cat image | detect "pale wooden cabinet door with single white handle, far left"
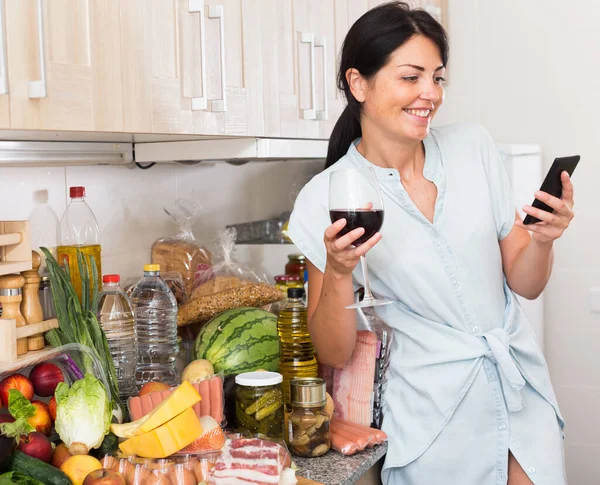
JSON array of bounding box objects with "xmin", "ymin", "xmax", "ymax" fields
[{"xmin": 5, "ymin": 0, "xmax": 123, "ymax": 132}]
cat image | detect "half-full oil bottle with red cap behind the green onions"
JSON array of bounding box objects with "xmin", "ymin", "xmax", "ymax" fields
[{"xmin": 56, "ymin": 187, "xmax": 102, "ymax": 301}]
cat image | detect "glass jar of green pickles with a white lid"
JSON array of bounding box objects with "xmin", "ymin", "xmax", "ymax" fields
[{"xmin": 235, "ymin": 372, "xmax": 283, "ymax": 439}]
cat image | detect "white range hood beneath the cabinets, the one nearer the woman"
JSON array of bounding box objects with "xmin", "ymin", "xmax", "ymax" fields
[{"xmin": 135, "ymin": 138, "xmax": 329, "ymax": 164}]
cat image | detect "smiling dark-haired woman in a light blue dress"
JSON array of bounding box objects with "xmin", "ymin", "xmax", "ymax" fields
[{"xmin": 289, "ymin": 2, "xmax": 573, "ymax": 485}]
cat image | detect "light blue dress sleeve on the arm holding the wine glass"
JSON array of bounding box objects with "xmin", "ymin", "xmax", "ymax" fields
[{"xmin": 288, "ymin": 175, "xmax": 331, "ymax": 273}]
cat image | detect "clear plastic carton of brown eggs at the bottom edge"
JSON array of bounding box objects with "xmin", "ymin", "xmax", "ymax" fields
[{"xmin": 101, "ymin": 452, "xmax": 221, "ymax": 485}]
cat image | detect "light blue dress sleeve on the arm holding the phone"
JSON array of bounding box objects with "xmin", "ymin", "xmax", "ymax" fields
[{"xmin": 481, "ymin": 128, "xmax": 516, "ymax": 241}]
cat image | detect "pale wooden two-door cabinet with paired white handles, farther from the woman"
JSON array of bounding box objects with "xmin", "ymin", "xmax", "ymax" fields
[{"xmin": 120, "ymin": 0, "xmax": 263, "ymax": 135}]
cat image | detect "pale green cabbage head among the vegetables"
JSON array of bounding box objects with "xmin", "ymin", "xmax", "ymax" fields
[{"xmin": 54, "ymin": 374, "xmax": 112, "ymax": 455}]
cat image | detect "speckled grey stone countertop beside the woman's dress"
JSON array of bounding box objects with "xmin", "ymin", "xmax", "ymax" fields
[{"xmin": 294, "ymin": 443, "xmax": 387, "ymax": 485}]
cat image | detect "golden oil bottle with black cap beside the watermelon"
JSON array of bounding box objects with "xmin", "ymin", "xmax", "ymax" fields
[{"xmin": 277, "ymin": 288, "xmax": 317, "ymax": 408}]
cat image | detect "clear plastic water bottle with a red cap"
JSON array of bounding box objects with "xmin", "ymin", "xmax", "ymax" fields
[{"xmin": 98, "ymin": 274, "xmax": 137, "ymax": 401}]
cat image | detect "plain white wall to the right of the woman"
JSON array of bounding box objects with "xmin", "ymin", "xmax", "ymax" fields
[{"xmin": 437, "ymin": 0, "xmax": 600, "ymax": 485}]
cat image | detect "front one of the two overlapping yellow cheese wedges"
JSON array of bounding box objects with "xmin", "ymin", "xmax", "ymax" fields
[{"xmin": 119, "ymin": 407, "xmax": 202, "ymax": 458}]
